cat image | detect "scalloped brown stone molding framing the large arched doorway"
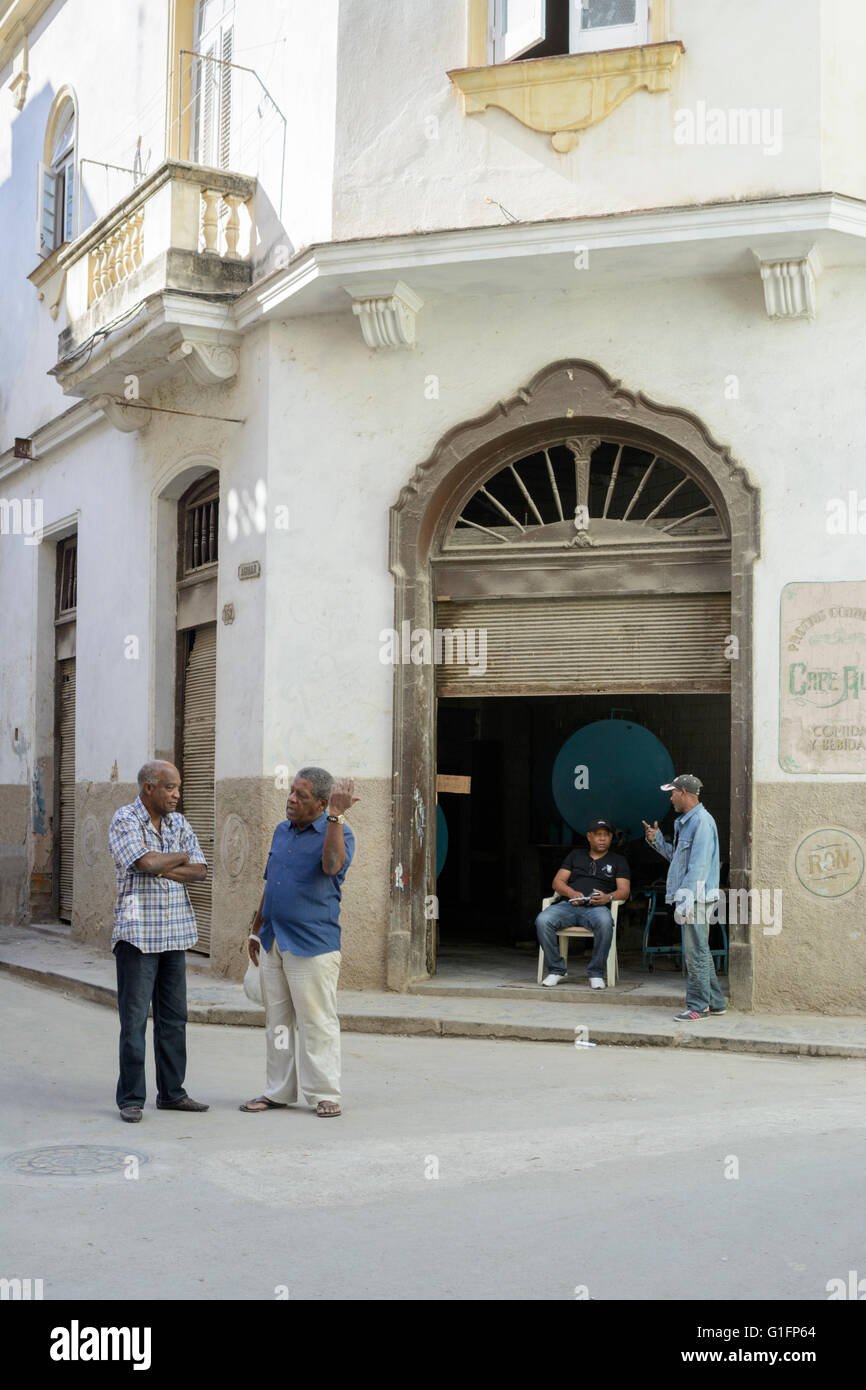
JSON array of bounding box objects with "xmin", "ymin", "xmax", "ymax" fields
[{"xmin": 388, "ymin": 359, "xmax": 760, "ymax": 1009}]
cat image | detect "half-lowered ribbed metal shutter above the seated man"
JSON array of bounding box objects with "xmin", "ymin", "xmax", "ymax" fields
[{"xmin": 433, "ymin": 594, "xmax": 731, "ymax": 695}]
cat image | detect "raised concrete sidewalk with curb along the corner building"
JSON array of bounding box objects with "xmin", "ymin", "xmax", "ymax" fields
[{"xmin": 0, "ymin": 926, "xmax": 866, "ymax": 1058}]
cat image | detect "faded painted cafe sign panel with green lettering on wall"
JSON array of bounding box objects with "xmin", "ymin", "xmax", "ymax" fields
[{"xmin": 778, "ymin": 581, "xmax": 866, "ymax": 773}]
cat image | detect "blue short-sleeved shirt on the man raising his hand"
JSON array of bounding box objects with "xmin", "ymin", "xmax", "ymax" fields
[{"xmin": 259, "ymin": 812, "xmax": 354, "ymax": 955}]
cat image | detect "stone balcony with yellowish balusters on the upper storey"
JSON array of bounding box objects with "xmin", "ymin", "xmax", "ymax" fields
[{"xmin": 44, "ymin": 161, "xmax": 256, "ymax": 414}]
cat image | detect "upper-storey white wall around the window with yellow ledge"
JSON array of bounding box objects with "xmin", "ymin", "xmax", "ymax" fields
[{"xmin": 335, "ymin": 0, "xmax": 834, "ymax": 238}]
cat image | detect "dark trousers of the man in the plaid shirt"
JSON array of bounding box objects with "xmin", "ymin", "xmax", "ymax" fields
[{"xmin": 114, "ymin": 941, "xmax": 186, "ymax": 1109}]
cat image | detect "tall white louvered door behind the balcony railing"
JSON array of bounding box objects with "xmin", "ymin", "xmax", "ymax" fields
[{"xmin": 193, "ymin": 0, "xmax": 235, "ymax": 170}]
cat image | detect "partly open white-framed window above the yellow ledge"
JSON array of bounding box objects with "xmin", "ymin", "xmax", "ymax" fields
[{"xmin": 488, "ymin": 0, "xmax": 649, "ymax": 63}]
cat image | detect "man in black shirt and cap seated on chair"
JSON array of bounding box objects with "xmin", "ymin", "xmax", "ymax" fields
[{"xmin": 535, "ymin": 820, "xmax": 631, "ymax": 990}]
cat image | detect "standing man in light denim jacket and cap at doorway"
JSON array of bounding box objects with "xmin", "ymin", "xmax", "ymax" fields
[{"xmin": 644, "ymin": 773, "xmax": 727, "ymax": 1023}]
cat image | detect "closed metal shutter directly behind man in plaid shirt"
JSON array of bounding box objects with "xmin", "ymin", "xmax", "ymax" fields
[{"xmin": 181, "ymin": 624, "xmax": 217, "ymax": 955}]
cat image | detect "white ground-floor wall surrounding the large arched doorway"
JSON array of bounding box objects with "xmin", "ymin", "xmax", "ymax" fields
[{"xmin": 254, "ymin": 255, "xmax": 866, "ymax": 781}]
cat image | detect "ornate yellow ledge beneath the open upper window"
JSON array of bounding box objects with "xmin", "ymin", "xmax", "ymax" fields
[{"xmin": 448, "ymin": 39, "xmax": 685, "ymax": 154}]
